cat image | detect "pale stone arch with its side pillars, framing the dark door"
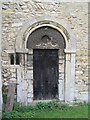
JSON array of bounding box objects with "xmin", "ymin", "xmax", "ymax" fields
[{"xmin": 15, "ymin": 16, "xmax": 76, "ymax": 104}]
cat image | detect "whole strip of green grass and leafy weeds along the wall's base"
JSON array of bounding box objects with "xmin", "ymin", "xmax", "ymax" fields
[{"xmin": 3, "ymin": 101, "xmax": 88, "ymax": 119}]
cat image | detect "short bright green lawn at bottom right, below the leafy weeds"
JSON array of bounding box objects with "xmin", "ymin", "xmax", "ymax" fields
[{"xmin": 33, "ymin": 106, "xmax": 88, "ymax": 118}]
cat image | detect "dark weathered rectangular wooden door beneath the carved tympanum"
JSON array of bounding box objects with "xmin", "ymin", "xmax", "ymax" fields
[{"xmin": 33, "ymin": 49, "xmax": 58, "ymax": 100}]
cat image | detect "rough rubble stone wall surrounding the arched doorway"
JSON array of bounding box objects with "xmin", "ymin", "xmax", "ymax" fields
[{"xmin": 2, "ymin": 0, "xmax": 88, "ymax": 101}]
